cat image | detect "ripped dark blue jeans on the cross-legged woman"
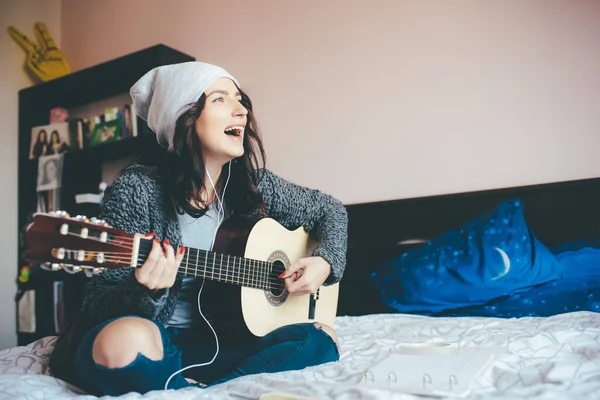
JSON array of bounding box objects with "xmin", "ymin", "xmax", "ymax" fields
[{"xmin": 75, "ymin": 320, "xmax": 339, "ymax": 396}]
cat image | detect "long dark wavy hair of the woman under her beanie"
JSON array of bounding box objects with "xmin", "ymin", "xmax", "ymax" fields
[{"xmin": 140, "ymin": 90, "xmax": 266, "ymax": 218}]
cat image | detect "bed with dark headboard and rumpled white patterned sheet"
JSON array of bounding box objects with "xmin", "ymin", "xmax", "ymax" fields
[{"xmin": 0, "ymin": 179, "xmax": 600, "ymax": 400}]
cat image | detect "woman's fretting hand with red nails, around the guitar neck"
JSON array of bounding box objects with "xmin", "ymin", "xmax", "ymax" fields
[{"xmin": 135, "ymin": 238, "xmax": 185, "ymax": 290}]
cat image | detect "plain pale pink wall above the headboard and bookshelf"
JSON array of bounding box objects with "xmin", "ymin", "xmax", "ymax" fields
[{"xmin": 62, "ymin": 0, "xmax": 600, "ymax": 203}]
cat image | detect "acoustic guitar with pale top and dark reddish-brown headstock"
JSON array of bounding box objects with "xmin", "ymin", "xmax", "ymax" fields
[{"xmin": 24, "ymin": 211, "xmax": 339, "ymax": 336}]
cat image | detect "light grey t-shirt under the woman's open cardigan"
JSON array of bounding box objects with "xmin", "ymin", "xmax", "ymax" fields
[{"xmin": 167, "ymin": 203, "xmax": 222, "ymax": 328}]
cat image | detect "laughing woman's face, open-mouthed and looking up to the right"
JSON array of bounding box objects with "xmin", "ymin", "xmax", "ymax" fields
[{"xmin": 196, "ymin": 78, "xmax": 248, "ymax": 166}]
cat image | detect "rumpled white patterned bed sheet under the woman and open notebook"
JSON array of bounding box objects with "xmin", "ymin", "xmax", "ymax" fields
[{"xmin": 0, "ymin": 312, "xmax": 600, "ymax": 400}]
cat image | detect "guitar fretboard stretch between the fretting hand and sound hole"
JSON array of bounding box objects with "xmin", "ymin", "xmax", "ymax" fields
[{"xmin": 179, "ymin": 247, "xmax": 276, "ymax": 290}]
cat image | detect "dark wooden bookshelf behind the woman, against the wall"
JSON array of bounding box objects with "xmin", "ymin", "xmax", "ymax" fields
[{"xmin": 16, "ymin": 44, "xmax": 195, "ymax": 345}]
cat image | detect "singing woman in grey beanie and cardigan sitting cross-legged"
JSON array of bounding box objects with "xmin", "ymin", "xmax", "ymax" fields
[{"xmin": 50, "ymin": 62, "xmax": 347, "ymax": 395}]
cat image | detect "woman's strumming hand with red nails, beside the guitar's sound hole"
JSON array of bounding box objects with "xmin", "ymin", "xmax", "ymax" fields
[{"xmin": 280, "ymin": 257, "xmax": 331, "ymax": 295}]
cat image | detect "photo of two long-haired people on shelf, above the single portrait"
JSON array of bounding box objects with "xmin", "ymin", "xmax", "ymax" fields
[{"xmin": 29, "ymin": 122, "xmax": 71, "ymax": 160}]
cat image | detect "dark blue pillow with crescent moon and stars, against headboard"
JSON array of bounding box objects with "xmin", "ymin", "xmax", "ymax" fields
[{"xmin": 370, "ymin": 200, "xmax": 560, "ymax": 314}]
